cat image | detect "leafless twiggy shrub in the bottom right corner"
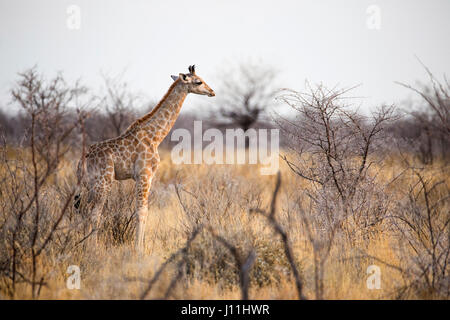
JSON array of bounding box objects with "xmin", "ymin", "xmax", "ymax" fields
[{"xmin": 390, "ymin": 169, "xmax": 450, "ymax": 299}]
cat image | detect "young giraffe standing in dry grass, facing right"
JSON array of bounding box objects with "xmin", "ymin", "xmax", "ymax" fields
[{"xmin": 74, "ymin": 65, "xmax": 215, "ymax": 248}]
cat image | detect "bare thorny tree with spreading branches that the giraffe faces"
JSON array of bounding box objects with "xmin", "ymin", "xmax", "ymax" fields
[{"xmin": 276, "ymin": 85, "xmax": 394, "ymax": 225}]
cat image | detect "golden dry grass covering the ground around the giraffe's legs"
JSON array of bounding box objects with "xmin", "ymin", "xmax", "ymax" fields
[{"xmin": 0, "ymin": 151, "xmax": 450, "ymax": 299}]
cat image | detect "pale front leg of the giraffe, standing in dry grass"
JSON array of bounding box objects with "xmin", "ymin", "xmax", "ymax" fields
[{"xmin": 135, "ymin": 172, "xmax": 153, "ymax": 249}]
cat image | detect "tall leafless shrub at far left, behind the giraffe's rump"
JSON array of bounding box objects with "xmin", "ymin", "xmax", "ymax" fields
[{"xmin": 0, "ymin": 69, "xmax": 86, "ymax": 298}]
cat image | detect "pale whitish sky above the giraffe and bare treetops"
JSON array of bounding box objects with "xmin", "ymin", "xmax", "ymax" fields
[{"xmin": 0, "ymin": 0, "xmax": 450, "ymax": 115}]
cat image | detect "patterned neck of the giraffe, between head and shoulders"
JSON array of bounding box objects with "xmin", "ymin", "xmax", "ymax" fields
[{"xmin": 128, "ymin": 80, "xmax": 188, "ymax": 146}]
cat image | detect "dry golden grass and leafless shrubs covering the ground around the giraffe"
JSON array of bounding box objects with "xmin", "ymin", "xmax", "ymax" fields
[{"xmin": 0, "ymin": 67, "xmax": 450, "ymax": 299}]
